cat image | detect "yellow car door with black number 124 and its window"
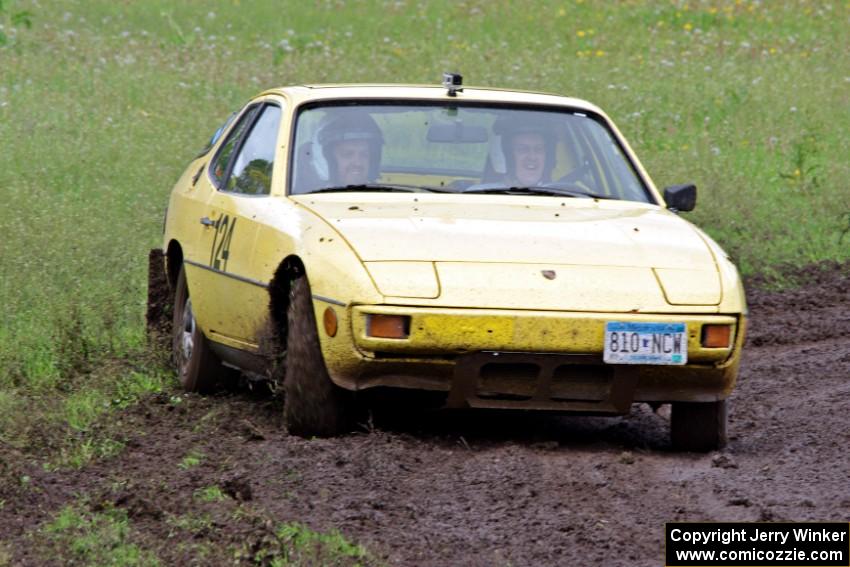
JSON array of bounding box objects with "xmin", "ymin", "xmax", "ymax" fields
[{"xmin": 190, "ymin": 100, "xmax": 282, "ymax": 350}]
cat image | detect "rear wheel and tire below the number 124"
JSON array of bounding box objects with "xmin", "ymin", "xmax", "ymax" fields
[{"xmin": 171, "ymin": 266, "xmax": 226, "ymax": 393}]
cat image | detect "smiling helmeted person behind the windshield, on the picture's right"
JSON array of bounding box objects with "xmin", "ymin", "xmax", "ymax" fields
[{"xmin": 493, "ymin": 117, "xmax": 555, "ymax": 187}]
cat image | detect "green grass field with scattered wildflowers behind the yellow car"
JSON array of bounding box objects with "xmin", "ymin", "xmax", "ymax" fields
[{"xmin": 0, "ymin": 0, "xmax": 850, "ymax": 560}]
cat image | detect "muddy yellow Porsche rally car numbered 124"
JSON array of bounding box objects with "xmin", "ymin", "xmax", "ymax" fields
[{"xmin": 149, "ymin": 74, "xmax": 746, "ymax": 450}]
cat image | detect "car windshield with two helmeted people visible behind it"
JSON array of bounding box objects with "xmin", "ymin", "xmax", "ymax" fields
[{"xmin": 291, "ymin": 102, "xmax": 652, "ymax": 202}]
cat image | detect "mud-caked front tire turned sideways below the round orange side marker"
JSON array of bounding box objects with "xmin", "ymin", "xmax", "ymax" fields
[{"xmin": 283, "ymin": 276, "xmax": 352, "ymax": 437}]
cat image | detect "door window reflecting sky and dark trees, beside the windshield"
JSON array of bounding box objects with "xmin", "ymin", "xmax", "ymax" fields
[{"xmin": 225, "ymin": 104, "xmax": 281, "ymax": 195}]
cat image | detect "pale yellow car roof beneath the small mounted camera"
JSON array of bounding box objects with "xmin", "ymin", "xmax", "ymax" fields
[{"xmin": 256, "ymin": 84, "xmax": 604, "ymax": 115}]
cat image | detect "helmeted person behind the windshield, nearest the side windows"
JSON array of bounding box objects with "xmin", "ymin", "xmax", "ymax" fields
[{"xmin": 317, "ymin": 110, "xmax": 384, "ymax": 186}]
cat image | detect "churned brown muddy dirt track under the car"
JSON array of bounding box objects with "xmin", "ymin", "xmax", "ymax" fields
[{"xmin": 0, "ymin": 267, "xmax": 850, "ymax": 566}]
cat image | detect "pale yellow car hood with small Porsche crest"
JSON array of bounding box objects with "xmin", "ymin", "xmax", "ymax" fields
[{"xmin": 294, "ymin": 193, "xmax": 721, "ymax": 310}]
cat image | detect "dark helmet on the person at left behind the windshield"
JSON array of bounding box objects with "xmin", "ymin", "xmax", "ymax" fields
[{"xmin": 316, "ymin": 109, "xmax": 384, "ymax": 179}]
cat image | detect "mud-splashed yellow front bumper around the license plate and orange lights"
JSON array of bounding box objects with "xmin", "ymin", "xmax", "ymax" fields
[{"xmin": 316, "ymin": 301, "xmax": 745, "ymax": 413}]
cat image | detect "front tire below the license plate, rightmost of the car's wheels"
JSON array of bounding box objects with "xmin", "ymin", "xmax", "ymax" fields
[{"xmin": 670, "ymin": 400, "xmax": 727, "ymax": 452}]
